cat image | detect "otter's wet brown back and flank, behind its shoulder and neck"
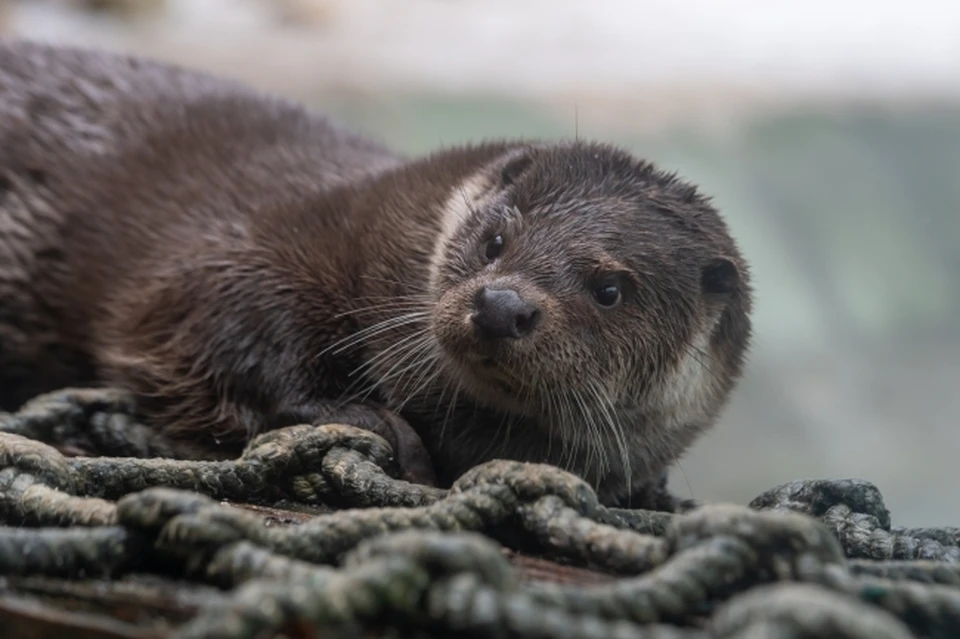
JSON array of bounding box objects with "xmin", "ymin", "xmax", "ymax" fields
[{"xmin": 0, "ymin": 41, "xmax": 397, "ymax": 410}]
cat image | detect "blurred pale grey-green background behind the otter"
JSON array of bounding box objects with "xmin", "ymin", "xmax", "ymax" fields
[{"xmin": 0, "ymin": 0, "xmax": 960, "ymax": 525}]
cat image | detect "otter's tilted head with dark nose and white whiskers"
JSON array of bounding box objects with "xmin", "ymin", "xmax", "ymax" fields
[{"xmin": 428, "ymin": 142, "xmax": 751, "ymax": 498}]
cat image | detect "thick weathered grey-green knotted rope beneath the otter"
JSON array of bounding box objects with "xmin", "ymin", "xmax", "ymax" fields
[{"xmin": 0, "ymin": 389, "xmax": 960, "ymax": 639}]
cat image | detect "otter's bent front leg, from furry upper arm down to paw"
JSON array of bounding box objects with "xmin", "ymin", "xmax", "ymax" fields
[{"xmin": 99, "ymin": 255, "xmax": 436, "ymax": 484}]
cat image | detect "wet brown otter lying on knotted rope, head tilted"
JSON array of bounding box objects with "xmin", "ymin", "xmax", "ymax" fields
[{"xmin": 0, "ymin": 40, "xmax": 752, "ymax": 505}]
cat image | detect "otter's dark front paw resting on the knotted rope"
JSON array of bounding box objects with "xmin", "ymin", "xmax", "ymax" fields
[{"xmin": 270, "ymin": 400, "xmax": 437, "ymax": 486}]
